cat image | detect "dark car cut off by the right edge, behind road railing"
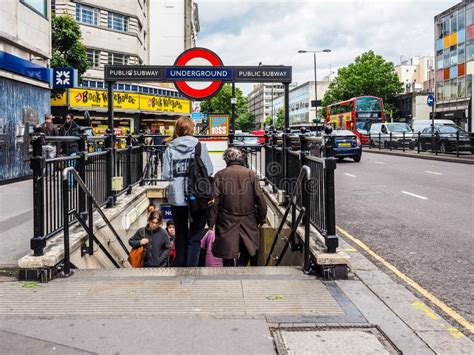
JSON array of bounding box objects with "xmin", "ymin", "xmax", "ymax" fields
[{"xmin": 420, "ymin": 126, "xmax": 474, "ymax": 153}]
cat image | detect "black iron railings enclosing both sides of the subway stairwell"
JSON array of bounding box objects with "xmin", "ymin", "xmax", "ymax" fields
[{"xmin": 31, "ymin": 134, "xmax": 338, "ymax": 262}]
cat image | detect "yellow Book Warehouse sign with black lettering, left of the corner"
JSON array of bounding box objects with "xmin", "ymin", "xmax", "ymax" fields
[{"xmin": 69, "ymin": 89, "xmax": 140, "ymax": 110}]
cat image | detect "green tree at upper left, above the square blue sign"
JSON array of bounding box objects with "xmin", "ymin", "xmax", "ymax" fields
[{"xmin": 51, "ymin": 15, "xmax": 91, "ymax": 97}]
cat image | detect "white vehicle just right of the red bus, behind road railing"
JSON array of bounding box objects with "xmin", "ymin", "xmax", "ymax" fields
[{"xmin": 369, "ymin": 123, "xmax": 416, "ymax": 149}]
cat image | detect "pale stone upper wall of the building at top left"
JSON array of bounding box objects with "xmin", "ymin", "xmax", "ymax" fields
[{"xmin": 0, "ymin": 0, "xmax": 51, "ymax": 66}]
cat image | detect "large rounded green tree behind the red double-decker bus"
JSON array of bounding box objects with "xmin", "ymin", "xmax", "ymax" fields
[{"xmin": 322, "ymin": 50, "xmax": 403, "ymax": 115}]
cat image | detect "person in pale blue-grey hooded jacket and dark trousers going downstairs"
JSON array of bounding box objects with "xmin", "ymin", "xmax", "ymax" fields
[{"xmin": 163, "ymin": 117, "xmax": 213, "ymax": 267}]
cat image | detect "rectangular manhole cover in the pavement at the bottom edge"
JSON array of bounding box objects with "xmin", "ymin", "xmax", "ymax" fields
[{"xmin": 271, "ymin": 326, "xmax": 401, "ymax": 355}]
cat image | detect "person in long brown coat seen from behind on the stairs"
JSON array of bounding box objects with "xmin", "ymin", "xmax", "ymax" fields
[{"xmin": 208, "ymin": 148, "xmax": 267, "ymax": 266}]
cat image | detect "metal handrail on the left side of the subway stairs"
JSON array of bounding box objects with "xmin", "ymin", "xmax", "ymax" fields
[{"xmin": 62, "ymin": 166, "xmax": 128, "ymax": 275}]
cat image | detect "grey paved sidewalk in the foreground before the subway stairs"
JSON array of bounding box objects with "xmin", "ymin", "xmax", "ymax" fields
[{"xmin": 0, "ymin": 266, "xmax": 474, "ymax": 354}]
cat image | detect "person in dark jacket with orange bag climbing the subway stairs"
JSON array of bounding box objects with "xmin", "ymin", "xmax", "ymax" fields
[{"xmin": 128, "ymin": 211, "xmax": 171, "ymax": 267}]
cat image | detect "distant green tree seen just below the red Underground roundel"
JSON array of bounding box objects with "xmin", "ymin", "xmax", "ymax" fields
[{"xmin": 201, "ymin": 84, "xmax": 250, "ymax": 131}]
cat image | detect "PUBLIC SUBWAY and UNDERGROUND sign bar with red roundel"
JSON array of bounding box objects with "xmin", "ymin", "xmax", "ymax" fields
[{"xmin": 104, "ymin": 48, "xmax": 292, "ymax": 100}]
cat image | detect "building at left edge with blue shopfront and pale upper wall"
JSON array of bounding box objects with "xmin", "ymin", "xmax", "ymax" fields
[{"xmin": 0, "ymin": 0, "xmax": 51, "ymax": 184}]
